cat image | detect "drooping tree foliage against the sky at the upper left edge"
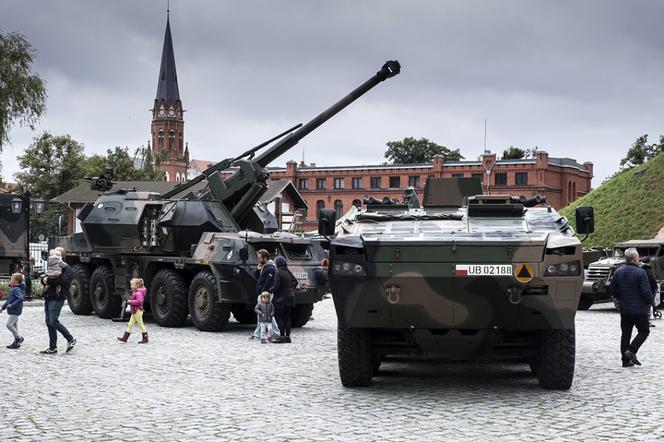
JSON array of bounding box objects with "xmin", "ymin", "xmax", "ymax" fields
[{"xmin": 0, "ymin": 33, "xmax": 46, "ymax": 152}]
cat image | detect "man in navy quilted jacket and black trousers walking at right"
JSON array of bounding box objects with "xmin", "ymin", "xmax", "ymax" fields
[{"xmin": 610, "ymin": 247, "xmax": 654, "ymax": 367}]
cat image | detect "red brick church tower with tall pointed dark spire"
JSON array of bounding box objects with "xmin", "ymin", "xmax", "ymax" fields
[{"xmin": 151, "ymin": 14, "xmax": 189, "ymax": 181}]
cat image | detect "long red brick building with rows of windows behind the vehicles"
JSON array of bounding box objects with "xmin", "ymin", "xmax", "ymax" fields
[{"xmin": 258, "ymin": 151, "xmax": 593, "ymax": 228}]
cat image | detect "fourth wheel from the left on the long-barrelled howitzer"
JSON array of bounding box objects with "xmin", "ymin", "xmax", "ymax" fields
[{"xmin": 189, "ymin": 272, "xmax": 232, "ymax": 331}]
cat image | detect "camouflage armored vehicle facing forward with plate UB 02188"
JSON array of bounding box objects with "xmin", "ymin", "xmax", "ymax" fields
[{"xmin": 319, "ymin": 179, "xmax": 594, "ymax": 389}]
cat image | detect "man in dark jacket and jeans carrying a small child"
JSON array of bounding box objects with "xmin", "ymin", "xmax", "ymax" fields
[{"xmin": 40, "ymin": 247, "xmax": 76, "ymax": 355}]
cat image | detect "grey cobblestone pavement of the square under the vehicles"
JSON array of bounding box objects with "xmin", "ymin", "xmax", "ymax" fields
[{"xmin": 0, "ymin": 299, "xmax": 664, "ymax": 441}]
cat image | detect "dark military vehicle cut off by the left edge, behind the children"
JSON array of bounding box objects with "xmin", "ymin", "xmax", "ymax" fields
[{"xmin": 0, "ymin": 193, "xmax": 26, "ymax": 276}]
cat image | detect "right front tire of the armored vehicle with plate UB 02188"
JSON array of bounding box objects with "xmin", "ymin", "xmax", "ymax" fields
[{"xmin": 535, "ymin": 329, "xmax": 576, "ymax": 390}]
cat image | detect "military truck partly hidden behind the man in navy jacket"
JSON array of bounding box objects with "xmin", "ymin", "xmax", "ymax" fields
[{"xmin": 579, "ymin": 239, "xmax": 664, "ymax": 310}]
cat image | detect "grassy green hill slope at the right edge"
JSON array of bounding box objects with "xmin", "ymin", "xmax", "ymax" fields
[{"xmin": 560, "ymin": 153, "xmax": 664, "ymax": 247}]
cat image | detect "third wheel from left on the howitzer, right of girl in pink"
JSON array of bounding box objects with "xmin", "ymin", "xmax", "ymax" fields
[{"xmin": 150, "ymin": 269, "xmax": 189, "ymax": 327}]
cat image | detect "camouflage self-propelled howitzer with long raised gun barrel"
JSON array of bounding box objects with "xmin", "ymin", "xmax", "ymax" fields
[{"xmin": 54, "ymin": 61, "xmax": 400, "ymax": 331}]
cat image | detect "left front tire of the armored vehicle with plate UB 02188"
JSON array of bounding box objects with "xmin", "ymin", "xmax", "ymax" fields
[{"xmin": 337, "ymin": 325, "xmax": 374, "ymax": 387}]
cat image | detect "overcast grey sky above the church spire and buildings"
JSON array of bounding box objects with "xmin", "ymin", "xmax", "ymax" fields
[{"xmin": 0, "ymin": 0, "xmax": 664, "ymax": 186}]
